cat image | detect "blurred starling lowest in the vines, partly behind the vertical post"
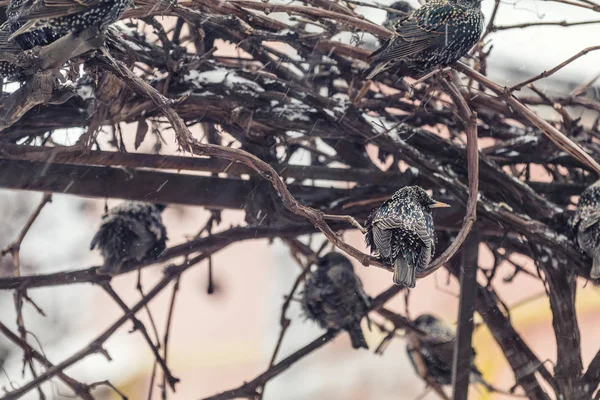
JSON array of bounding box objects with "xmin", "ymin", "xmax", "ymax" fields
[{"xmin": 406, "ymin": 314, "xmax": 490, "ymax": 391}]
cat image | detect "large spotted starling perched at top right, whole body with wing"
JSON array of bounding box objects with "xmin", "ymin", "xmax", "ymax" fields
[{"xmin": 366, "ymin": 0, "xmax": 484, "ymax": 79}]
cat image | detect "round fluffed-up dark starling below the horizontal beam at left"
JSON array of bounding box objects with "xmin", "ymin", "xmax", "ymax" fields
[{"xmin": 90, "ymin": 202, "xmax": 167, "ymax": 275}]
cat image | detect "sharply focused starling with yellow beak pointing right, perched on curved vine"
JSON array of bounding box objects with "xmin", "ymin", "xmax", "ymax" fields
[{"xmin": 366, "ymin": 186, "xmax": 450, "ymax": 288}]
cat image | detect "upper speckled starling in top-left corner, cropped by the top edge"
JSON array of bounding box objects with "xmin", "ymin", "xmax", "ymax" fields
[{"xmin": 6, "ymin": 0, "xmax": 132, "ymax": 50}]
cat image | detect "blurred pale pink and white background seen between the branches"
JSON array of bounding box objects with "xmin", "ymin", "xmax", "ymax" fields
[{"xmin": 0, "ymin": 0, "xmax": 600, "ymax": 400}]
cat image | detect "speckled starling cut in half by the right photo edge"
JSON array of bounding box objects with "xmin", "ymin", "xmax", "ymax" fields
[{"xmin": 571, "ymin": 181, "xmax": 600, "ymax": 279}]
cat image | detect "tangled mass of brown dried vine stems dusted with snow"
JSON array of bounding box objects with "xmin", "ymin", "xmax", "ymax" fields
[{"xmin": 0, "ymin": 0, "xmax": 600, "ymax": 400}]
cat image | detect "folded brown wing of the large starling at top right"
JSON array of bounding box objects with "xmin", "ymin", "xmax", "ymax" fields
[{"xmin": 369, "ymin": 5, "xmax": 456, "ymax": 63}]
